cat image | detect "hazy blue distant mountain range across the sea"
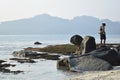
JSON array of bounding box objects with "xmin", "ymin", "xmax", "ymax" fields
[{"xmin": 0, "ymin": 14, "xmax": 120, "ymax": 35}]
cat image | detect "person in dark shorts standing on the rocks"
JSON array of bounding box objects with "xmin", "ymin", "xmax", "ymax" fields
[{"xmin": 99, "ymin": 23, "xmax": 106, "ymax": 46}]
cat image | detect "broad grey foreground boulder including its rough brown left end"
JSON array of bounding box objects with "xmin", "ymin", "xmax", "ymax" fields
[{"xmin": 57, "ymin": 55, "xmax": 112, "ymax": 72}]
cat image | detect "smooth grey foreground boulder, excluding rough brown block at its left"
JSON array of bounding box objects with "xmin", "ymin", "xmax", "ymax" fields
[{"xmin": 70, "ymin": 55, "xmax": 113, "ymax": 72}]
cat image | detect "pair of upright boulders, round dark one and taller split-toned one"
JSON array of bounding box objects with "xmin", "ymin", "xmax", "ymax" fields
[{"xmin": 70, "ymin": 35, "xmax": 96, "ymax": 54}]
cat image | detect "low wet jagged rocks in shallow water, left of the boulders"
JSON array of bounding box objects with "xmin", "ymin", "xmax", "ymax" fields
[{"xmin": 0, "ymin": 50, "xmax": 60, "ymax": 74}]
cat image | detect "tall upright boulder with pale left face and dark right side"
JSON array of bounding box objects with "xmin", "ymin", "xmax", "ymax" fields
[{"xmin": 80, "ymin": 36, "xmax": 96, "ymax": 54}]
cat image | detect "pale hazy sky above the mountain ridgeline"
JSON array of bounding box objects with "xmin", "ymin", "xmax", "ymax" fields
[{"xmin": 0, "ymin": 0, "xmax": 120, "ymax": 22}]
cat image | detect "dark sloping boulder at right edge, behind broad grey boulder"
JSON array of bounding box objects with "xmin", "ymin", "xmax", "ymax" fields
[{"xmin": 89, "ymin": 47, "xmax": 120, "ymax": 66}]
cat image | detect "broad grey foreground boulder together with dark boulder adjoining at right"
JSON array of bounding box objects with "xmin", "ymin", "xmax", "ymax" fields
[{"xmin": 57, "ymin": 47, "xmax": 120, "ymax": 72}]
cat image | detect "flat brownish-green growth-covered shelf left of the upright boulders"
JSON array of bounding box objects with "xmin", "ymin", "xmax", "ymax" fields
[{"xmin": 25, "ymin": 44, "xmax": 76, "ymax": 55}]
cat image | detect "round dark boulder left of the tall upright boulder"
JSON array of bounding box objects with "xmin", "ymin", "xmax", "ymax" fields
[{"xmin": 70, "ymin": 35, "xmax": 83, "ymax": 46}]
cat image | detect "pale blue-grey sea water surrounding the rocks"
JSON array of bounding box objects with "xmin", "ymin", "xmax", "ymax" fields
[{"xmin": 0, "ymin": 34, "xmax": 120, "ymax": 80}]
